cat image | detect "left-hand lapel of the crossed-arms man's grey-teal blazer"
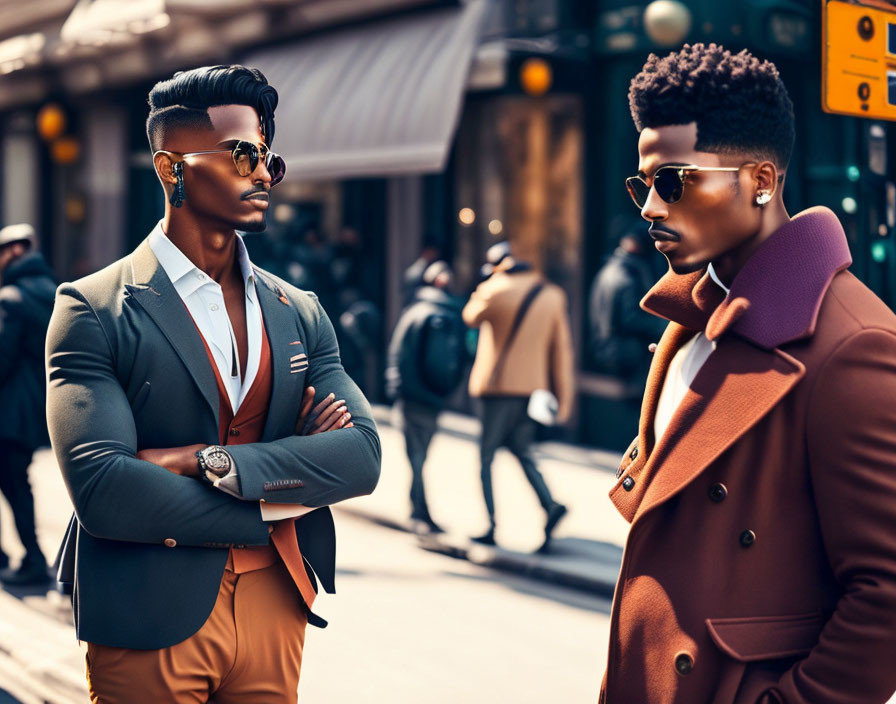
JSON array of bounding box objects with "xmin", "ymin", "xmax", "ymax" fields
[{"xmin": 125, "ymin": 240, "xmax": 218, "ymax": 426}]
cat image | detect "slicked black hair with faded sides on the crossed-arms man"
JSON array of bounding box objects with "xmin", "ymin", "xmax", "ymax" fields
[{"xmin": 146, "ymin": 65, "xmax": 278, "ymax": 153}]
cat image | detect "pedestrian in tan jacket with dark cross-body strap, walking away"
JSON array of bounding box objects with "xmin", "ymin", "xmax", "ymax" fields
[{"xmin": 463, "ymin": 248, "xmax": 575, "ymax": 552}]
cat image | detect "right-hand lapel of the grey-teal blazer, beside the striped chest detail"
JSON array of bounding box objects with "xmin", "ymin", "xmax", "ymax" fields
[{"xmin": 255, "ymin": 269, "xmax": 308, "ymax": 441}]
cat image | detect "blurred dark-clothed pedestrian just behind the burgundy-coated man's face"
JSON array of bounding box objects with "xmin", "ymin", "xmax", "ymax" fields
[{"xmin": 588, "ymin": 215, "xmax": 666, "ymax": 385}]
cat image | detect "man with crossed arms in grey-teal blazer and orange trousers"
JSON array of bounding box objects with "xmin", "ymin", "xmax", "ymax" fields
[{"xmin": 47, "ymin": 66, "xmax": 380, "ymax": 704}]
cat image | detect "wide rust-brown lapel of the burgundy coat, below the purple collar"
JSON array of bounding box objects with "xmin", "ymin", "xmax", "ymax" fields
[{"xmin": 634, "ymin": 335, "xmax": 805, "ymax": 520}]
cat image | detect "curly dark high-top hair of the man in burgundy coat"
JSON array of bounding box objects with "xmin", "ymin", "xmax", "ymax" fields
[{"xmin": 628, "ymin": 44, "xmax": 794, "ymax": 171}]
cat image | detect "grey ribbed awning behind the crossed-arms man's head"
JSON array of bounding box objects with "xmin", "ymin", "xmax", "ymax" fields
[{"xmin": 242, "ymin": 0, "xmax": 485, "ymax": 180}]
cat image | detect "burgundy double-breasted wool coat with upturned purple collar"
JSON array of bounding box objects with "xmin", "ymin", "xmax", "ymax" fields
[{"xmin": 600, "ymin": 208, "xmax": 896, "ymax": 704}]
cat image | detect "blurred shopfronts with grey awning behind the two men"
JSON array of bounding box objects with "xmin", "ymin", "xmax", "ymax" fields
[{"xmin": 0, "ymin": 0, "xmax": 880, "ymax": 449}]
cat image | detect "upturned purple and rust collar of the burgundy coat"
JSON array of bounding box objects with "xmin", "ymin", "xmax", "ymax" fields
[{"xmin": 641, "ymin": 207, "xmax": 852, "ymax": 349}]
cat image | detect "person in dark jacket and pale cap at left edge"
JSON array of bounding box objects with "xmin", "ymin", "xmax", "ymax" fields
[{"xmin": 0, "ymin": 224, "xmax": 56, "ymax": 585}]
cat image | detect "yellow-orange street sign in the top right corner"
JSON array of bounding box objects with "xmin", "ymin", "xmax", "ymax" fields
[{"xmin": 821, "ymin": 0, "xmax": 896, "ymax": 120}]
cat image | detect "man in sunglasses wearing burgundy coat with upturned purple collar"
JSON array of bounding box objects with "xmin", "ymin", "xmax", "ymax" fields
[{"xmin": 600, "ymin": 44, "xmax": 896, "ymax": 704}]
